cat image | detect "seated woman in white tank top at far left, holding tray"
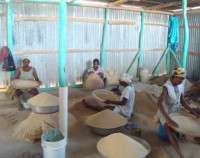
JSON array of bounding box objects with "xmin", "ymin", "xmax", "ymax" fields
[{"xmin": 15, "ymin": 58, "xmax": 41, "ymax": 108}]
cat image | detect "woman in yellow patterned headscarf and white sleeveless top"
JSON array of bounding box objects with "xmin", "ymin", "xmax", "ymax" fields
[{"xmin": 157, "ymin": 68, "xmax": 199, "ymax": 158}]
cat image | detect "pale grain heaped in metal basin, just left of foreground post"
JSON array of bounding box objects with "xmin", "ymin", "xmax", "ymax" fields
[{"xmin": 28, "ymin": 92, "xmax": 58, "ymax": 107}]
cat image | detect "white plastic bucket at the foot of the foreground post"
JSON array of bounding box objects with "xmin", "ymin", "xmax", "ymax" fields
[{"xmin": 42, "ymin": 135, "xmax": 67, "ymax": 158}]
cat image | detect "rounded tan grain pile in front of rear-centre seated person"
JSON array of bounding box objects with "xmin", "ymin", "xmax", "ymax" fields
[{"xmin": 84, "ymin": 73, "xmax": 104, "ymax": 90}]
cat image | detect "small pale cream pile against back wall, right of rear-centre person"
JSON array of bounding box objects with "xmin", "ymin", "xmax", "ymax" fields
[{"xmin": 106, "ymin": 70, "xmax": 119, "ymax": 85}]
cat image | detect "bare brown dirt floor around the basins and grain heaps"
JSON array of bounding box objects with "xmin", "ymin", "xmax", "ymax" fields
[{"xmin": 0, "ymin": 89, "xmax": 200, "ymax": 158}]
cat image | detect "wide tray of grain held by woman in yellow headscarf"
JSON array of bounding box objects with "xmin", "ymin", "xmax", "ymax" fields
[{"xmin": 170, "ymin": 113, "xmax": 200, "ymax": 137}]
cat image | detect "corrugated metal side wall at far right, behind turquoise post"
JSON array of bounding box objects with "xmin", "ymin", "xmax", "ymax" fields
[{"xmin": 180, "ymin": 13, "xmax": 200, "ymax": 80}]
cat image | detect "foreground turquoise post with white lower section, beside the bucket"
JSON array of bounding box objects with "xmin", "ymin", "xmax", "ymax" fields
[{"xmin": 58, "ymin": 0, "xmax": 68, "ymax": 140}]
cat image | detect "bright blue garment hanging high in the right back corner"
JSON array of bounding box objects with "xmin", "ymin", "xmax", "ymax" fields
[{"xmin": 168, "ymin": 16, "xmax": 179, "ymax": 52}]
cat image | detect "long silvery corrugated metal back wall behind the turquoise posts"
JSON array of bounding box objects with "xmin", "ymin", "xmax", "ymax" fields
[{"xmin": 0, "ymin": 3, "xmax": 168, "ymax": 86}]
